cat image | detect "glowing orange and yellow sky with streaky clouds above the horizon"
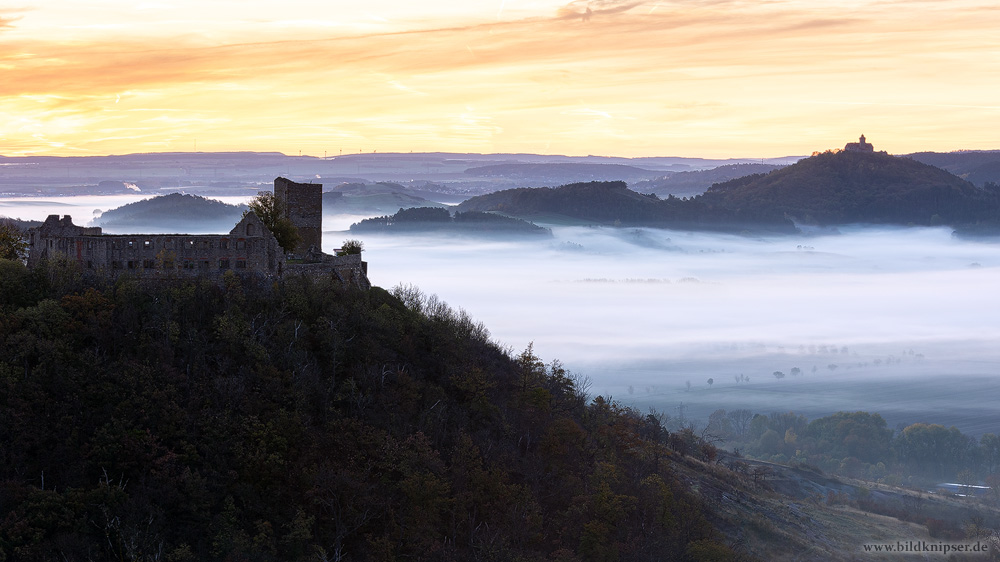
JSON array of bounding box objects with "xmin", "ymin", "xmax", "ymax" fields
[{"xmin": 0, "ymin": 0, "xmax": 1000, "ymax": 157}]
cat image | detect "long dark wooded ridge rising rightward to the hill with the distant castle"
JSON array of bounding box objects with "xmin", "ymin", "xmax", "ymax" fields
[{"xmin": 458, "ymin": 152, "xmax": 1000, "ymax": 232}]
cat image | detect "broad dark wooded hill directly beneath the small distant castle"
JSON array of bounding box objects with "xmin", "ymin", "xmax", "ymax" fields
[{"xmin": 704, "ymin": 152, "xmax": 997, "ymax": 225}]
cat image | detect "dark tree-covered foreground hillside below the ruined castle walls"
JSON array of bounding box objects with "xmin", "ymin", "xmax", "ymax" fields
[{"xmin": 0, "ymin": 260, "xmax": 742, "ymax": 561}]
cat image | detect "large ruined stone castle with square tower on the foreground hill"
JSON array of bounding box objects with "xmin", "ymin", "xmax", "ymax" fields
[{"xmin": 28, "ymin": 177, "xmax": 371, "ymax": 289}]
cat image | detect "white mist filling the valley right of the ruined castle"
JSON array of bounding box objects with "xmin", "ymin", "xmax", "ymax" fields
[{"xmin": 324, "ymin": 222, "xmax": 1000, "ymax": 434}]
